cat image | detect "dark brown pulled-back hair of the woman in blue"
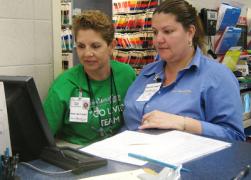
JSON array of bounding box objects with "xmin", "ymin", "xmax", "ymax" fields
[{"xmin": 153, "ymin": 0, "xmax": 205, "ymax": 50}]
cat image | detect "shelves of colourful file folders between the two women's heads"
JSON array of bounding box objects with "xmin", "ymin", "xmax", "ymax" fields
[{"xmin": 112, "ymin": 0, "xmax": 158, "ymax": 73}]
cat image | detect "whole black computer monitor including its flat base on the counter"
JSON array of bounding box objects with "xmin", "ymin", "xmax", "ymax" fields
[{"xmin": 0, "ymin": 76, "xmax": 107, "ymax": 173}]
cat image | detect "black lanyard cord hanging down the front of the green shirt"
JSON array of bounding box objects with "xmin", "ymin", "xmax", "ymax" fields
[{"xmin": 85, "ymin": 68, "xmax": 121, "ymax": 131}]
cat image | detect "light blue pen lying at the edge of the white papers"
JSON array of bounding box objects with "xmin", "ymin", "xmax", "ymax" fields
[{"xmin": 128, "ymin": 153, "xmax": 191, "ymax": 172}]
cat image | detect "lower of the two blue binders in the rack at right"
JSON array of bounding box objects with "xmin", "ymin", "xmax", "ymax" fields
[{"xmin": 215, "ymin": 26, "xmax": 242, "ymax": 54}]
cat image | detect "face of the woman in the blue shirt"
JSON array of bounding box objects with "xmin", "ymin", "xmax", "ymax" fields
[{"xmin": 152, "ymin": 13, "xmax": 194, "ymax": 62}]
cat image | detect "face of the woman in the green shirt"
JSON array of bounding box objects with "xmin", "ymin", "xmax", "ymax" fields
[{"xmin": 76, "ymin": 29, "xmax": 113, "ymax": 72}]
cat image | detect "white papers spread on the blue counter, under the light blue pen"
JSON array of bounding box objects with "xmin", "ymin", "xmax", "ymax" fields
[{"xmin": 81, "ymin": 130, "xmax": 231, "ymax": 165}]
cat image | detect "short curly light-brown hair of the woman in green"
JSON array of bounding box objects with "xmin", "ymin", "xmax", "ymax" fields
[{"xmin": 73, "ymin": 10, "xmax": 114, "ymax": 44}]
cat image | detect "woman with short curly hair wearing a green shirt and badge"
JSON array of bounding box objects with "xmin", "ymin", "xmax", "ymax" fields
[{"xmin": 44, "ymin": 10, "xmax": 135, "ymax": 145}]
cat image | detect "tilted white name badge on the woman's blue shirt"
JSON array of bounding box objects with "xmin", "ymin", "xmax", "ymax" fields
[{"xmin": 137, "ymin": 83, "xmax": 161, "ymax": 101}]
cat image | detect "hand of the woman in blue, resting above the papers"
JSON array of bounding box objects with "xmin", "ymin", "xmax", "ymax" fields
[{"xmin": 139, "ymin": 110, "xmax": 185, "ymax": 131}]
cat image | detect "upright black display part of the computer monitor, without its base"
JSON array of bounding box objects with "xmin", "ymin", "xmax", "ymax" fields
[{"xmin": 0, "ymin": 76, "xmax": 55, "ymax": 161}]
